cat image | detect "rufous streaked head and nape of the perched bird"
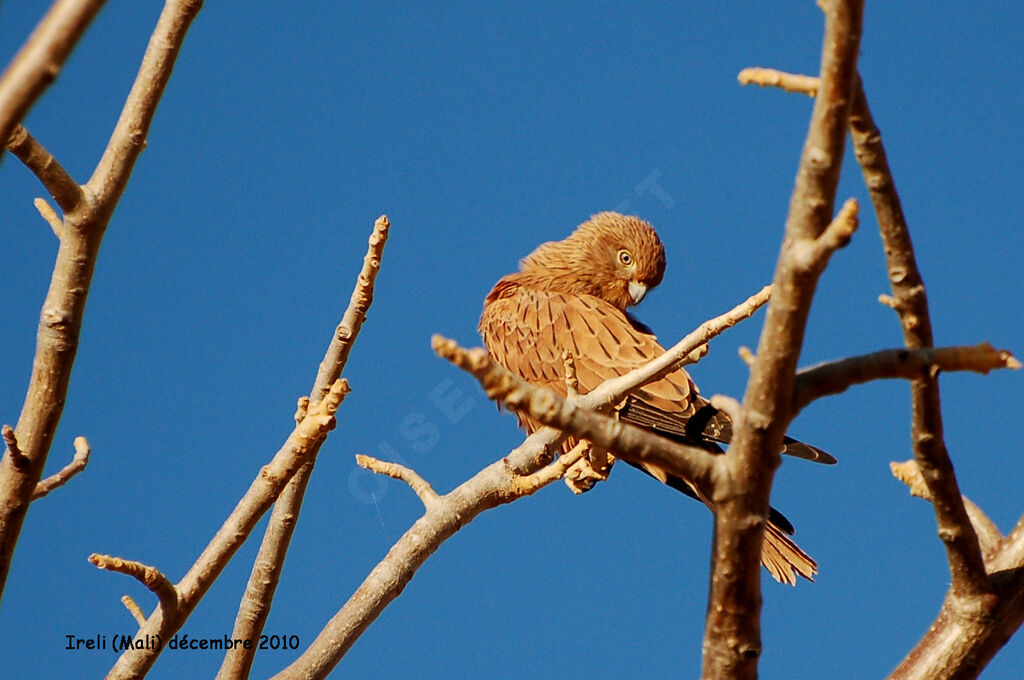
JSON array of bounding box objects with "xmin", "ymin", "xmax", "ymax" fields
[{"xmin": 520, "ymin": 212, "xmax": 665, "ymax": 310}]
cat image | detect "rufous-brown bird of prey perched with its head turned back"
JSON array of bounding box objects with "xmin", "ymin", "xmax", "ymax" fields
[{"xmin": 479, "ymin": 212, "xmax": 836, "ymax": 584}]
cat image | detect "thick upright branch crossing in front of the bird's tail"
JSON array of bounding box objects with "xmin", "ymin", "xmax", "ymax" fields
[{"xmin": 701, "ymin": 0, "xmax": 863, "ymax": 679}]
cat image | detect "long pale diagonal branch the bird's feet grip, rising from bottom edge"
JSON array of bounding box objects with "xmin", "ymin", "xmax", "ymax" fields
[{"xmin": 273, "ymin": 289, "xmax": 769, "ymax": 680}]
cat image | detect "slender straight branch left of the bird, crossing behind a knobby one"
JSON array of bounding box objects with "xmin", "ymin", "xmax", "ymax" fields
[{"xmin": 217, "ymin": 215, "xmax": 390, "ymax": 680}]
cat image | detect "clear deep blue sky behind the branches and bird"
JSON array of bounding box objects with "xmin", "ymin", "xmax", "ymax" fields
[{"xmin": 0, "ymin": 0, "xmax": 1024, "ymax": 678}]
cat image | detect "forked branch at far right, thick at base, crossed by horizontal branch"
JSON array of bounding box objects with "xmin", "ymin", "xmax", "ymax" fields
[{"xmin": 740, "ymin": 29, "xmax": 1024, "ymax": 680}]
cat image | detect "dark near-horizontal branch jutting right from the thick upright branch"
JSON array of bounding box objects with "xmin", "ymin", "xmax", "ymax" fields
[{"xmin": 793, "ymin": 342, "xmax": 1021, "ymax": 415}]
